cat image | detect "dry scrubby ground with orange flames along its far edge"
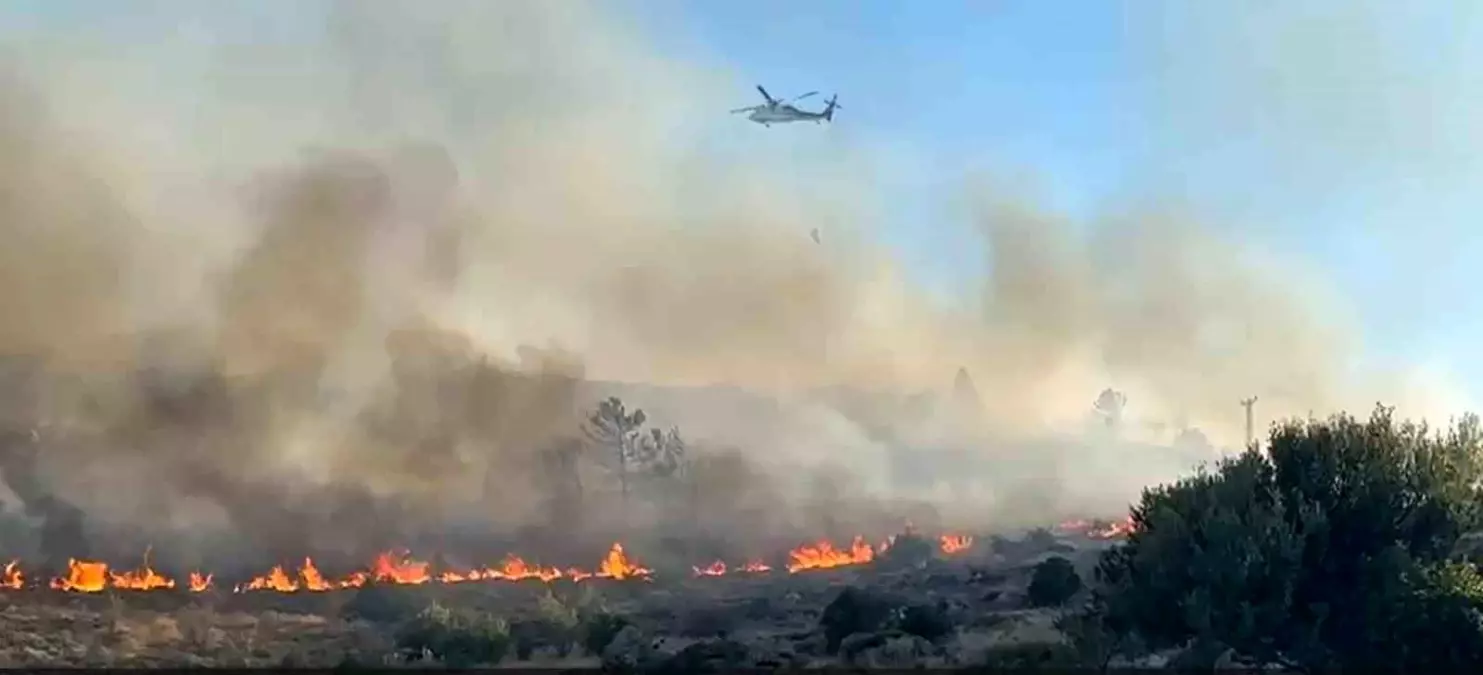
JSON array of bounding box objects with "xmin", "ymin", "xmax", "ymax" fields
[{"xmin": 0, "ymin": 522, "xmax": 1121, "ymax": 668}]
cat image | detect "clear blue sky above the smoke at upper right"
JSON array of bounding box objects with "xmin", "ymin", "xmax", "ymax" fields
[{"xmin": 638, "ymin": 0, "xmax": 1483, "ymax": 399}]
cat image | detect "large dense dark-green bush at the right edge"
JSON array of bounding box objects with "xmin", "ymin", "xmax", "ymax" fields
[{"xmin": 1093, "ymin": 408, "xmax": 1483, "ymax": 669}]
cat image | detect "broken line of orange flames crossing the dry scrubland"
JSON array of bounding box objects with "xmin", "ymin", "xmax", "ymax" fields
[{"xmin": 0, "ymin": 534, "xmax": 973, "ymax": 593}]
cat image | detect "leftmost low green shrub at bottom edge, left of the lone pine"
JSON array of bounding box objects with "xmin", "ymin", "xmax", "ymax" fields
[{"xmin": 396, "ymin": 602, "xmax": 510, "ymax": 668}]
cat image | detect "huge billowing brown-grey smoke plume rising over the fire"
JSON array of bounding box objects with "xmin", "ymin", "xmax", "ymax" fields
[{"xmin": 0, "ymin": 0, "xmax": 1465, "ymax": 572}]
